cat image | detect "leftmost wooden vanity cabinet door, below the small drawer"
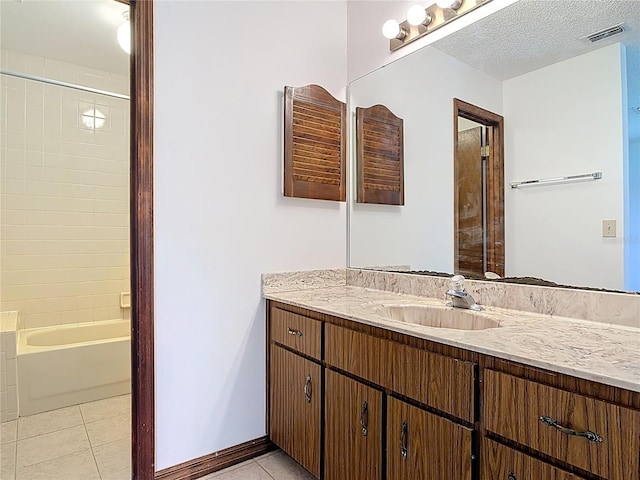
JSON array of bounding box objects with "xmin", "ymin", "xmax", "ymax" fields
[{"xmin": 270, "ymin": 344, "xmax": 322, "ymax": 478}]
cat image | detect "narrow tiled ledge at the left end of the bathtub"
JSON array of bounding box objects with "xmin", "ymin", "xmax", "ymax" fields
[{"xmin": 0, "ymin": 312, "xmax": 18, "ymax": 420}]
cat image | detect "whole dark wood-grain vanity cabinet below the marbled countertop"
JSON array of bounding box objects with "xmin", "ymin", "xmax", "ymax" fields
[{"xmin": 267, "ymin": 301, "xmax": 640, "ymax": 480}]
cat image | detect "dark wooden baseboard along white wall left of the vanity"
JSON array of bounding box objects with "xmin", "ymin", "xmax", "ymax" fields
[{"xmin": 154, "ymin": 436, "xmax": 276, "ymax": 480}]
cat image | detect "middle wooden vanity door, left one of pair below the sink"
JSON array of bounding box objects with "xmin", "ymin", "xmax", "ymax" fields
[{"xmin": 324, "ymin": 370, "xmax": 382, "ymax": 480}]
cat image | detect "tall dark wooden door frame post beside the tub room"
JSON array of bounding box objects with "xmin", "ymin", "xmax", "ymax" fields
[{"xmin": 130, "ymin": 0, "xmax": 155, "ymax": 480}]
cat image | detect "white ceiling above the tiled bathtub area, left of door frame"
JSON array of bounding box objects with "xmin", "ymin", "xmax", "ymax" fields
[{"xmin": 0, "ymin": 0, "xmax": 129, "ymax": 76}]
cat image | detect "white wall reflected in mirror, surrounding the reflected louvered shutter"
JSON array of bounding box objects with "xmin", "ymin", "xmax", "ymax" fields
[{"xmin": 349, "ymin": 47, "xmax": 502, "ymax": 272}]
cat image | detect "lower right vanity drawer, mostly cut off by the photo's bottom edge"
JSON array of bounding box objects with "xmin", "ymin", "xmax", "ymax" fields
[{"xmin": 481, "ymin": 438, "xmax": 582, "ymax": 480}]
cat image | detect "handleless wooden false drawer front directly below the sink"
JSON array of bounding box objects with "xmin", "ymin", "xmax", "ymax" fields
[{"xmin": 325, "ymin": 324, "xmax": 475, "ymax": 423}]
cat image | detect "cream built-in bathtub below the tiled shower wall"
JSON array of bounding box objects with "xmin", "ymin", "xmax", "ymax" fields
[{"xmin": 17, "ymin": 320, "xmax": 131, "ymax": 416}]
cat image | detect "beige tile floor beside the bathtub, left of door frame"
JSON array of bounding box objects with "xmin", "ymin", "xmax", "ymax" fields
[{"xmin": 0, "ymin": 395, "xmax": 131, "ymax": 480}]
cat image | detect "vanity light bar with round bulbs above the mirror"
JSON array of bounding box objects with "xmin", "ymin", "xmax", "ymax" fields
[{"xmin": 382, "ymin": 0, "xmax": 492, "ymax": 51}]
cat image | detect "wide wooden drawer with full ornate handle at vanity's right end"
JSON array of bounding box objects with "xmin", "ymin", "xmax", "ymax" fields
[{"xmin": 483, "ymin": 370, "xmax": 640, "ymax": 480}]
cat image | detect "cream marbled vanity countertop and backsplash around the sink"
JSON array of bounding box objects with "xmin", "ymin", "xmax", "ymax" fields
[{"xmin": 264, "ymin": 269, "xmax": 640, "ymax": 392}]
